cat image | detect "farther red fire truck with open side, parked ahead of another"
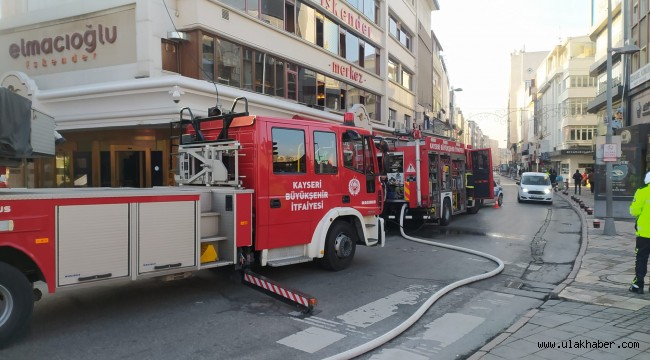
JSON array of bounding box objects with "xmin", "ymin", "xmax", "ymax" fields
[{"xmin": 381, "ymin": 132, "xmax": 494, "ymax": 227}]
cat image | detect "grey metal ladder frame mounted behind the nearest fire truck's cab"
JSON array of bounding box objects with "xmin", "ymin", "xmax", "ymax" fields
[{"xmin": 170, "ymin": 97, "xmax": 248, "ymax": 187}]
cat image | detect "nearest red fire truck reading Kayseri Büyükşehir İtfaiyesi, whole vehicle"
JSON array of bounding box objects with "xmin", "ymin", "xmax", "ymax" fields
[{"xmin": 0, "ymin": 95, "xmax": 385, "ymax": 344}]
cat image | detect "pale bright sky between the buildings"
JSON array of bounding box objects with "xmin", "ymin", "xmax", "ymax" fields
[{"xmin": 431, "ymin": 0, "xmax": 592, "ymax": 147}]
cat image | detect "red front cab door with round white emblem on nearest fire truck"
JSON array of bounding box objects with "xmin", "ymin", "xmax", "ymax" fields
[{"xmin": 341, "ymin": 130, "xmax": 380, "ymax": 215}]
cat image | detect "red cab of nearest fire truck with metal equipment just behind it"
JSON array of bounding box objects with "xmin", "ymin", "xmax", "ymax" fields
[{"xmin": 177, "ymin": 97, "xmax": 384, "ymax": 270}]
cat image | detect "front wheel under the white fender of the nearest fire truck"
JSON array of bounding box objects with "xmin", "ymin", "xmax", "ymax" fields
[{"xmin": 321, "ymin": 221, "xmax": 357, "ymax": 271}]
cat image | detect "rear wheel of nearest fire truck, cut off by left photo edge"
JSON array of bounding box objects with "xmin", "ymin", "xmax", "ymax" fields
[{"xmin": 0, "ymin": 262, "xmax": 34, "ymax": 349}]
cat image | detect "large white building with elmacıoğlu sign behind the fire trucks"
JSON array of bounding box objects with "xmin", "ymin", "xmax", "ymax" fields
[{"xmin": 0, "ymin": 0, "xmax": 439, "ymax": 187}]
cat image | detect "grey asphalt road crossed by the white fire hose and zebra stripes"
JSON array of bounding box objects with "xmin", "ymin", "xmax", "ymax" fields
[{"xmin": 0, "ymin": 179, "xmax": 580, "ymax": 360}]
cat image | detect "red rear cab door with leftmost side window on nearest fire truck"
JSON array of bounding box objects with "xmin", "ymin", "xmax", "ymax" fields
[{"xmin": 264, "ymin": 123, "xmax": 314, "ymax": 250}]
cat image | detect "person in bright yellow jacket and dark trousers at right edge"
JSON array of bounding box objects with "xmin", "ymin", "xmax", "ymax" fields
[{"xmin": 629, "ymin": 172, "xmax": 650, "ymax": 294}]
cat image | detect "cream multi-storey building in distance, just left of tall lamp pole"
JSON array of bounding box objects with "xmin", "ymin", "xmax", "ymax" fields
[{"xmin": 530, "ymin": 35, "xmax": 598, "ymax": 177}]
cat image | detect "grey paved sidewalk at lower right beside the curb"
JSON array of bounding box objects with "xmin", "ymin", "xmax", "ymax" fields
[{"xmin": 469, "ymin": 184, "xmax": 650, "ymax": 360}]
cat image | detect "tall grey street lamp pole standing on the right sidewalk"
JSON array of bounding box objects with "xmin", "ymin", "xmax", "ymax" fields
[{"xmin": 603, "ymin": 0, "xmax": 640, "ymax": 235}]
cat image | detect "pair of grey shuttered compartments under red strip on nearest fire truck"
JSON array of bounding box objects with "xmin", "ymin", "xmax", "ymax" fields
[{"xmin": 53, "ymin": 189, "xmax": 199, "ymax": 286}]
